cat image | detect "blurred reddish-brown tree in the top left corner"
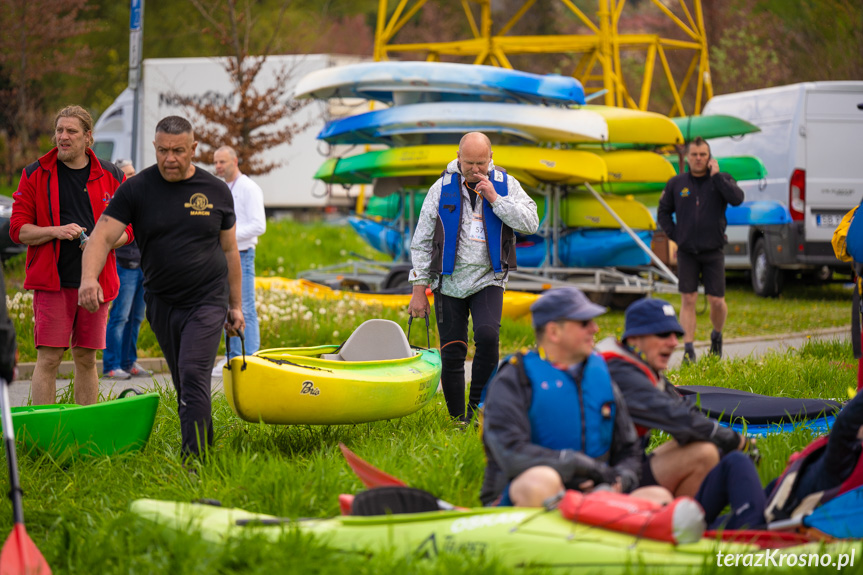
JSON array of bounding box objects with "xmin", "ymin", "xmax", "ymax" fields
[{"xmin": 0, "ymin": 0, "xmax": 96, "ymax": 184}]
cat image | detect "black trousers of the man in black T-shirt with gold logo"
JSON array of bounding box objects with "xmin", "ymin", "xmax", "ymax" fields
[{"xmin": 145, "ymin": 293, "xmax": 227, "ymax": 456}]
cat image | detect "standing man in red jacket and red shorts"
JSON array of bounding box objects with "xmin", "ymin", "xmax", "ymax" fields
[{"xmin": 9, "ymin": 106, "xmax": 132, "ymax": 405}]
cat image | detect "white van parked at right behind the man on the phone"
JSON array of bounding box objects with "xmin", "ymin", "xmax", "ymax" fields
[{"xmin": 703, "ymin": 82, "xmax": 863, "ymax": 297}]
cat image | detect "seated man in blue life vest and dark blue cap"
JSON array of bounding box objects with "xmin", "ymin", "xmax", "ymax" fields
[{"xmin": 480, "ymin": 287, "xmax": 671, "ymax": 507}]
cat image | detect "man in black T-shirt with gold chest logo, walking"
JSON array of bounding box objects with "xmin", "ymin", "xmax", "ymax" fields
[{"xmin": 79, "ymin": 116, "xmax": 245, "ymax": 455}]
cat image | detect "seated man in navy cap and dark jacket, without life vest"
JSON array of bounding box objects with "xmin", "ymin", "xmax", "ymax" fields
[{"xmin": 597, "ymin": 299, "xmax": 747, "ymax": 497}]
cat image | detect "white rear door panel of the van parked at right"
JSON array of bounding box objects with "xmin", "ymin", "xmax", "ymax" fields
[{"xmin": 802, "ymin": 83, "xmax": 863, "ymax": 243}]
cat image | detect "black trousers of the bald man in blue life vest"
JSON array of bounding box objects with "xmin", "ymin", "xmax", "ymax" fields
[{"xmin": 435, "ymin": 286, "xmax": 503, "ymax": 417}]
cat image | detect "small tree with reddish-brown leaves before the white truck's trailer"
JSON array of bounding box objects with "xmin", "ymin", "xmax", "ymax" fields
[{"xmin": 179, "ymin": 0, "xmax": 310, "ymax": 175}]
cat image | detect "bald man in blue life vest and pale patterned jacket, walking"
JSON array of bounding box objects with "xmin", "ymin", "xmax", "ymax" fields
[{"xmin": 408, "ymin": 132, "xmax": 539, "ymax": 423}]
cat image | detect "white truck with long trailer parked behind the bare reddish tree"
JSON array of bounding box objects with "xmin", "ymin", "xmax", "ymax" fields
[{"xmin": 93, "ymin": 54, "xmax": 367, "ymax": 210}]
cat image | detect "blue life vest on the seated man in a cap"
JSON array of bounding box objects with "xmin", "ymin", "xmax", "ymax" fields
[{"xmin": 523, "ymin": 351, "xmax": 617, "ymax": 459}]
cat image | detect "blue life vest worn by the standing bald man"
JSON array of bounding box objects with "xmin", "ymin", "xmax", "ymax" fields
[{"xmin": 432, "ymin": 168, "xmax": 515, "ymax": 276}]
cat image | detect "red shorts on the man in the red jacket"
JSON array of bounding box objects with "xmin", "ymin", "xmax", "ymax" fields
[{"xmin": 33, "ymin": 288, "xmax": 110, "ymax": 349}]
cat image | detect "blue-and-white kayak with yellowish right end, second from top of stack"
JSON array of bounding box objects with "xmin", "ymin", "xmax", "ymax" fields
[{"xmin": 318, "ymin": 102, "xmax": 608, "ymax": 148}]
